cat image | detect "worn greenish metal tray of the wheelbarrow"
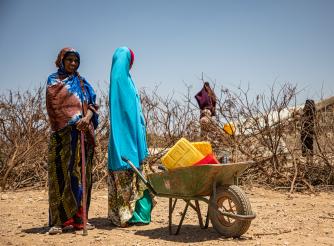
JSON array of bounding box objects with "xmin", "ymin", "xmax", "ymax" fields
[{"xmin": 148, "ymin": 161, "xmax": 252, "ymax": 197}]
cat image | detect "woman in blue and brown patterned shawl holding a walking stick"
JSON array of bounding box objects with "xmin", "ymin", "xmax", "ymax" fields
[{"xmin": 46, "ymin": 48, "xmax": 98, "ymax": 234}]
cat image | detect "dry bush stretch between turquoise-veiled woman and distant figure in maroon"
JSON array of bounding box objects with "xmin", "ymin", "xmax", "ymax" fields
[{"xmin": 140, "ymin": 85, "xmax": 199, "ymax": 166}]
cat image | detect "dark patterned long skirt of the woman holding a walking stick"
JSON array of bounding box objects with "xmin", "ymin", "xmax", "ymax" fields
[{"xmin": 48, "ymin": 126, "xmax": 94, "ymax": 226}]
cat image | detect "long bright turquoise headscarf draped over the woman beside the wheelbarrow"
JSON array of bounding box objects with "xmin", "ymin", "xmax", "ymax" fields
[{"xmin": 108, "ymin": 47, "xmax": 148, "ymax": 171}]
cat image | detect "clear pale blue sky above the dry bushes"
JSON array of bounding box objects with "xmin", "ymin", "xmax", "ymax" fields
[{"xmin": 0, "ymin": 0, "xmax": 334, "ymax": 100}]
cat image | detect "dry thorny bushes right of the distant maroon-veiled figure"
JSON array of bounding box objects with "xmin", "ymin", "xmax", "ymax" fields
[{"xmin": 201, "ymin": 81, "xmax": 334, "ymax": 191}]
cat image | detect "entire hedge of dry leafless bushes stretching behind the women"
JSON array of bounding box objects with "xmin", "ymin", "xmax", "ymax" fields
[{"xmin": 0, "ymin": 81, "xmax": 334, "ymax": 191}]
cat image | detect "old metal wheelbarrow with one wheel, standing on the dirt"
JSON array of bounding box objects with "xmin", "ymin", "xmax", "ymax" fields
[{"xmin": 122, "ymin": 157, "xmax": 256, "ymax": 237}]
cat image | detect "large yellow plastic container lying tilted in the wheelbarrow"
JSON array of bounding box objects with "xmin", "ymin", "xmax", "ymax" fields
[{"xmin": 161, "ymin": 138, "xmax": 204, "ymax": 169}]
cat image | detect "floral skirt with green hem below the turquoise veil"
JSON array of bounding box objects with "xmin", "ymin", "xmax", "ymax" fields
[{"xmin": 108, "ymin": 167, "xmax": 153, "ymax": 227}]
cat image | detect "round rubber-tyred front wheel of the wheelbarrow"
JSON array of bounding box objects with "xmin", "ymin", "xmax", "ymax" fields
[{"xmin": 209, "ymin": 185, "xmax": 252, "ymax": 237}]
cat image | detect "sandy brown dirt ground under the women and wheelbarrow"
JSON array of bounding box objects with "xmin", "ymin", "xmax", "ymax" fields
[{"xmin": 0, "ymin": 187, "xmax": 334, "ymax": 245}]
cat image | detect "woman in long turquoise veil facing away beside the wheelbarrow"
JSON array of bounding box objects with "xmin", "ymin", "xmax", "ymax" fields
[{"xmin": 108, "ymin": 47, "xmax": 153, "ymax": 227}]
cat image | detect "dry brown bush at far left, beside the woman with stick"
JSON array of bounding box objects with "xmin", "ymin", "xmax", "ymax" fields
[{"xmin": 0, "ymin": 88, "xmax": 49, "ymax": 190}]
